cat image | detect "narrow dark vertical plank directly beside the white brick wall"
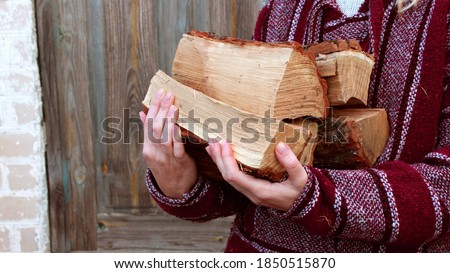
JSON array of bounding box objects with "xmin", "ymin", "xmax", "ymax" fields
[{"xmin": 36, "ymin": 0, "xmax": 68, "ymax": 252}]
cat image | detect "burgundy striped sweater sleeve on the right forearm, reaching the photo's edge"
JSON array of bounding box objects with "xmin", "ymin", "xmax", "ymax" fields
[{"xmin": 274, "ymin": 154, "xmax": 450, "ymax": 248}]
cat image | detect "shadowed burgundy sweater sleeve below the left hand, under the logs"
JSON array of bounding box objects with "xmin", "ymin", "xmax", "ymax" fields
[{"xmin": 147, "ymin": 169, "xmax": 243, "ymax": 222}]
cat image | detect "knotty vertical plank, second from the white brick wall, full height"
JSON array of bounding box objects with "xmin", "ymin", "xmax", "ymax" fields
[{"xmin": 58, "ymin": 0, "xmax": 97, "ymax": 251}]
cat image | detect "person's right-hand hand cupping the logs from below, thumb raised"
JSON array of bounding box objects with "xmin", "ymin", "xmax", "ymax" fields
[{"xmin": 206, "ymin": 138, "xmax": 308, "ymax": 211}]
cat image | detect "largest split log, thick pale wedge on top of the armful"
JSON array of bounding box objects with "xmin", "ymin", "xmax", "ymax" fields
[{"xmin": 172, "ymin": 34, "xmax": 326, "ymax": 119}]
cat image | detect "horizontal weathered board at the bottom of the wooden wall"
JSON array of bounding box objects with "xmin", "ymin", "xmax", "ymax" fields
[{"xmin": 98, "ymin": 213, "xmax": 233, "ymax": 253}]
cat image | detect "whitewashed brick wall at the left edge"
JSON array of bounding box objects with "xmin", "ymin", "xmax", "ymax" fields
[{"xmin": 0, "ymin": 0, "xmax": 50, "ymax": 252}]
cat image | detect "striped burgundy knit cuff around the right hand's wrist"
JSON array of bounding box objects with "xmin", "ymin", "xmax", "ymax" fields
[{"xmin": 270, "ymin": 167, "xmax": 319, "ymax": 219}]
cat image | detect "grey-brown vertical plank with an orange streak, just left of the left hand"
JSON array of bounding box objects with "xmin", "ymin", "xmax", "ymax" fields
[{"xmin": 98, "ymin": 0, "xmax": 158, "ymax": 210}]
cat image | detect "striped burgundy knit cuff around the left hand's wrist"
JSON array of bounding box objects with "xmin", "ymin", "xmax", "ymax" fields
[{"xmin": 147, "ymin": 169, "xmax": 209, "ymax": 207}]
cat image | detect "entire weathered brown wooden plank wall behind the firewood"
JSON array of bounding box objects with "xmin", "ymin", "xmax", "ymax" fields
[{"xmin": 35, "ymin": 0, "xmax": 264, "ymax": 252}]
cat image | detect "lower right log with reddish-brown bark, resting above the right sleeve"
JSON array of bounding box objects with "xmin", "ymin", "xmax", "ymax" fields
[{"xmin": 314, "ymin": 109, "xmax": 390, "ymax": 170}]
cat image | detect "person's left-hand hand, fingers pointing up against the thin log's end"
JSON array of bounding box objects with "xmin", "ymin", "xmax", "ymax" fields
[{"xmin": 139, "ymin": 90, "xmax": 198, "ymax": 198}]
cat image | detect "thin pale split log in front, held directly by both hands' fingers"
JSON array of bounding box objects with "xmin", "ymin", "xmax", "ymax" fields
[{"xmin": 143, "ymin": 71, "xmax": 311, "ymax": 176}]
